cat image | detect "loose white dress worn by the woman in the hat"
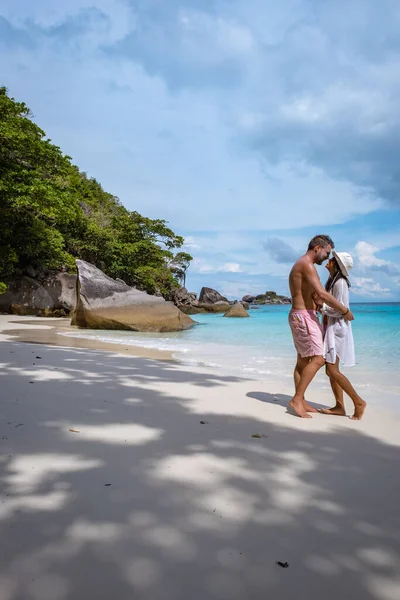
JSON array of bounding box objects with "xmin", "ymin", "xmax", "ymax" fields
[{"xmin": 321, "ymin": 278, "xmax": 355, "ymax": 367}]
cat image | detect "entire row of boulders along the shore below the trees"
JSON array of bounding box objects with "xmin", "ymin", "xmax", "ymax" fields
[{"xmin": 0, "ymin": 260, "xmax": 291, "ymax": 332}]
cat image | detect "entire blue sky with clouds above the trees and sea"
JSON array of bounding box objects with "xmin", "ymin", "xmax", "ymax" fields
[{"xmin": 0, "ymin": 0, "xmax": 400, "ymax": 301}]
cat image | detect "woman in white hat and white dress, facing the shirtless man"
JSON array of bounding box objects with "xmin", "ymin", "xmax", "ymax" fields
[{"xmin": 320, "ymin": 251, "xmax": 367, "ymax": 421}]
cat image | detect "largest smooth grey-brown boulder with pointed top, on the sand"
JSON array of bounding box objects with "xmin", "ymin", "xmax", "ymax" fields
[{"xmin": 72, "ymin": 260, "xmax": 194, "ymax": 332}]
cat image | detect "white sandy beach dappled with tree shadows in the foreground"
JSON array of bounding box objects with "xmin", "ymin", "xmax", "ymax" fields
[{"xmin": 0, "ymin": 315, "xmax": 400, "ymax": 600}]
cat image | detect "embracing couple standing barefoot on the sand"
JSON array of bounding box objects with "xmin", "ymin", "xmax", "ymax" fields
[{"xmin": 289, "ymin": 235, "xmax": 366, "ymax": 420}]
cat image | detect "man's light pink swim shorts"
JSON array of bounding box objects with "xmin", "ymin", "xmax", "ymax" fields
[{"xmin": 289, "ymin": 308, "xmax": 323, "ymax": 358}]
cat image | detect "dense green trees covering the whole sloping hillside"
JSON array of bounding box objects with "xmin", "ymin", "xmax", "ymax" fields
[{"xmin": 0, "ymin": 87, "xmax": 192, "ymax": 297}]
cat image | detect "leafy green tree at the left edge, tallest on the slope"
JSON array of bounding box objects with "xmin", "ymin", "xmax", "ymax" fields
[{"xmin": 0, "ymin": 88, "xmax": 79, "ymax": 278}]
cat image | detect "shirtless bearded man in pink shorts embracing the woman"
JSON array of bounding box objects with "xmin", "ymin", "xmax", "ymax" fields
[{"xmin": 289, "ymin": 235, "xmax": 354, "ymax": 419}]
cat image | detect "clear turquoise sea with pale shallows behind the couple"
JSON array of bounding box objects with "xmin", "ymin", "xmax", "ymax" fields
[{"xmin": 62, "ymin": 303, "xmax": 400, "ymax": 405}]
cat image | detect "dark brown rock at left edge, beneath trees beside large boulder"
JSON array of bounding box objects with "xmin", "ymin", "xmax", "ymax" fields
[{"xmin": 0, "ymin": 267, "xmax": 76, "ymax": 317}]
